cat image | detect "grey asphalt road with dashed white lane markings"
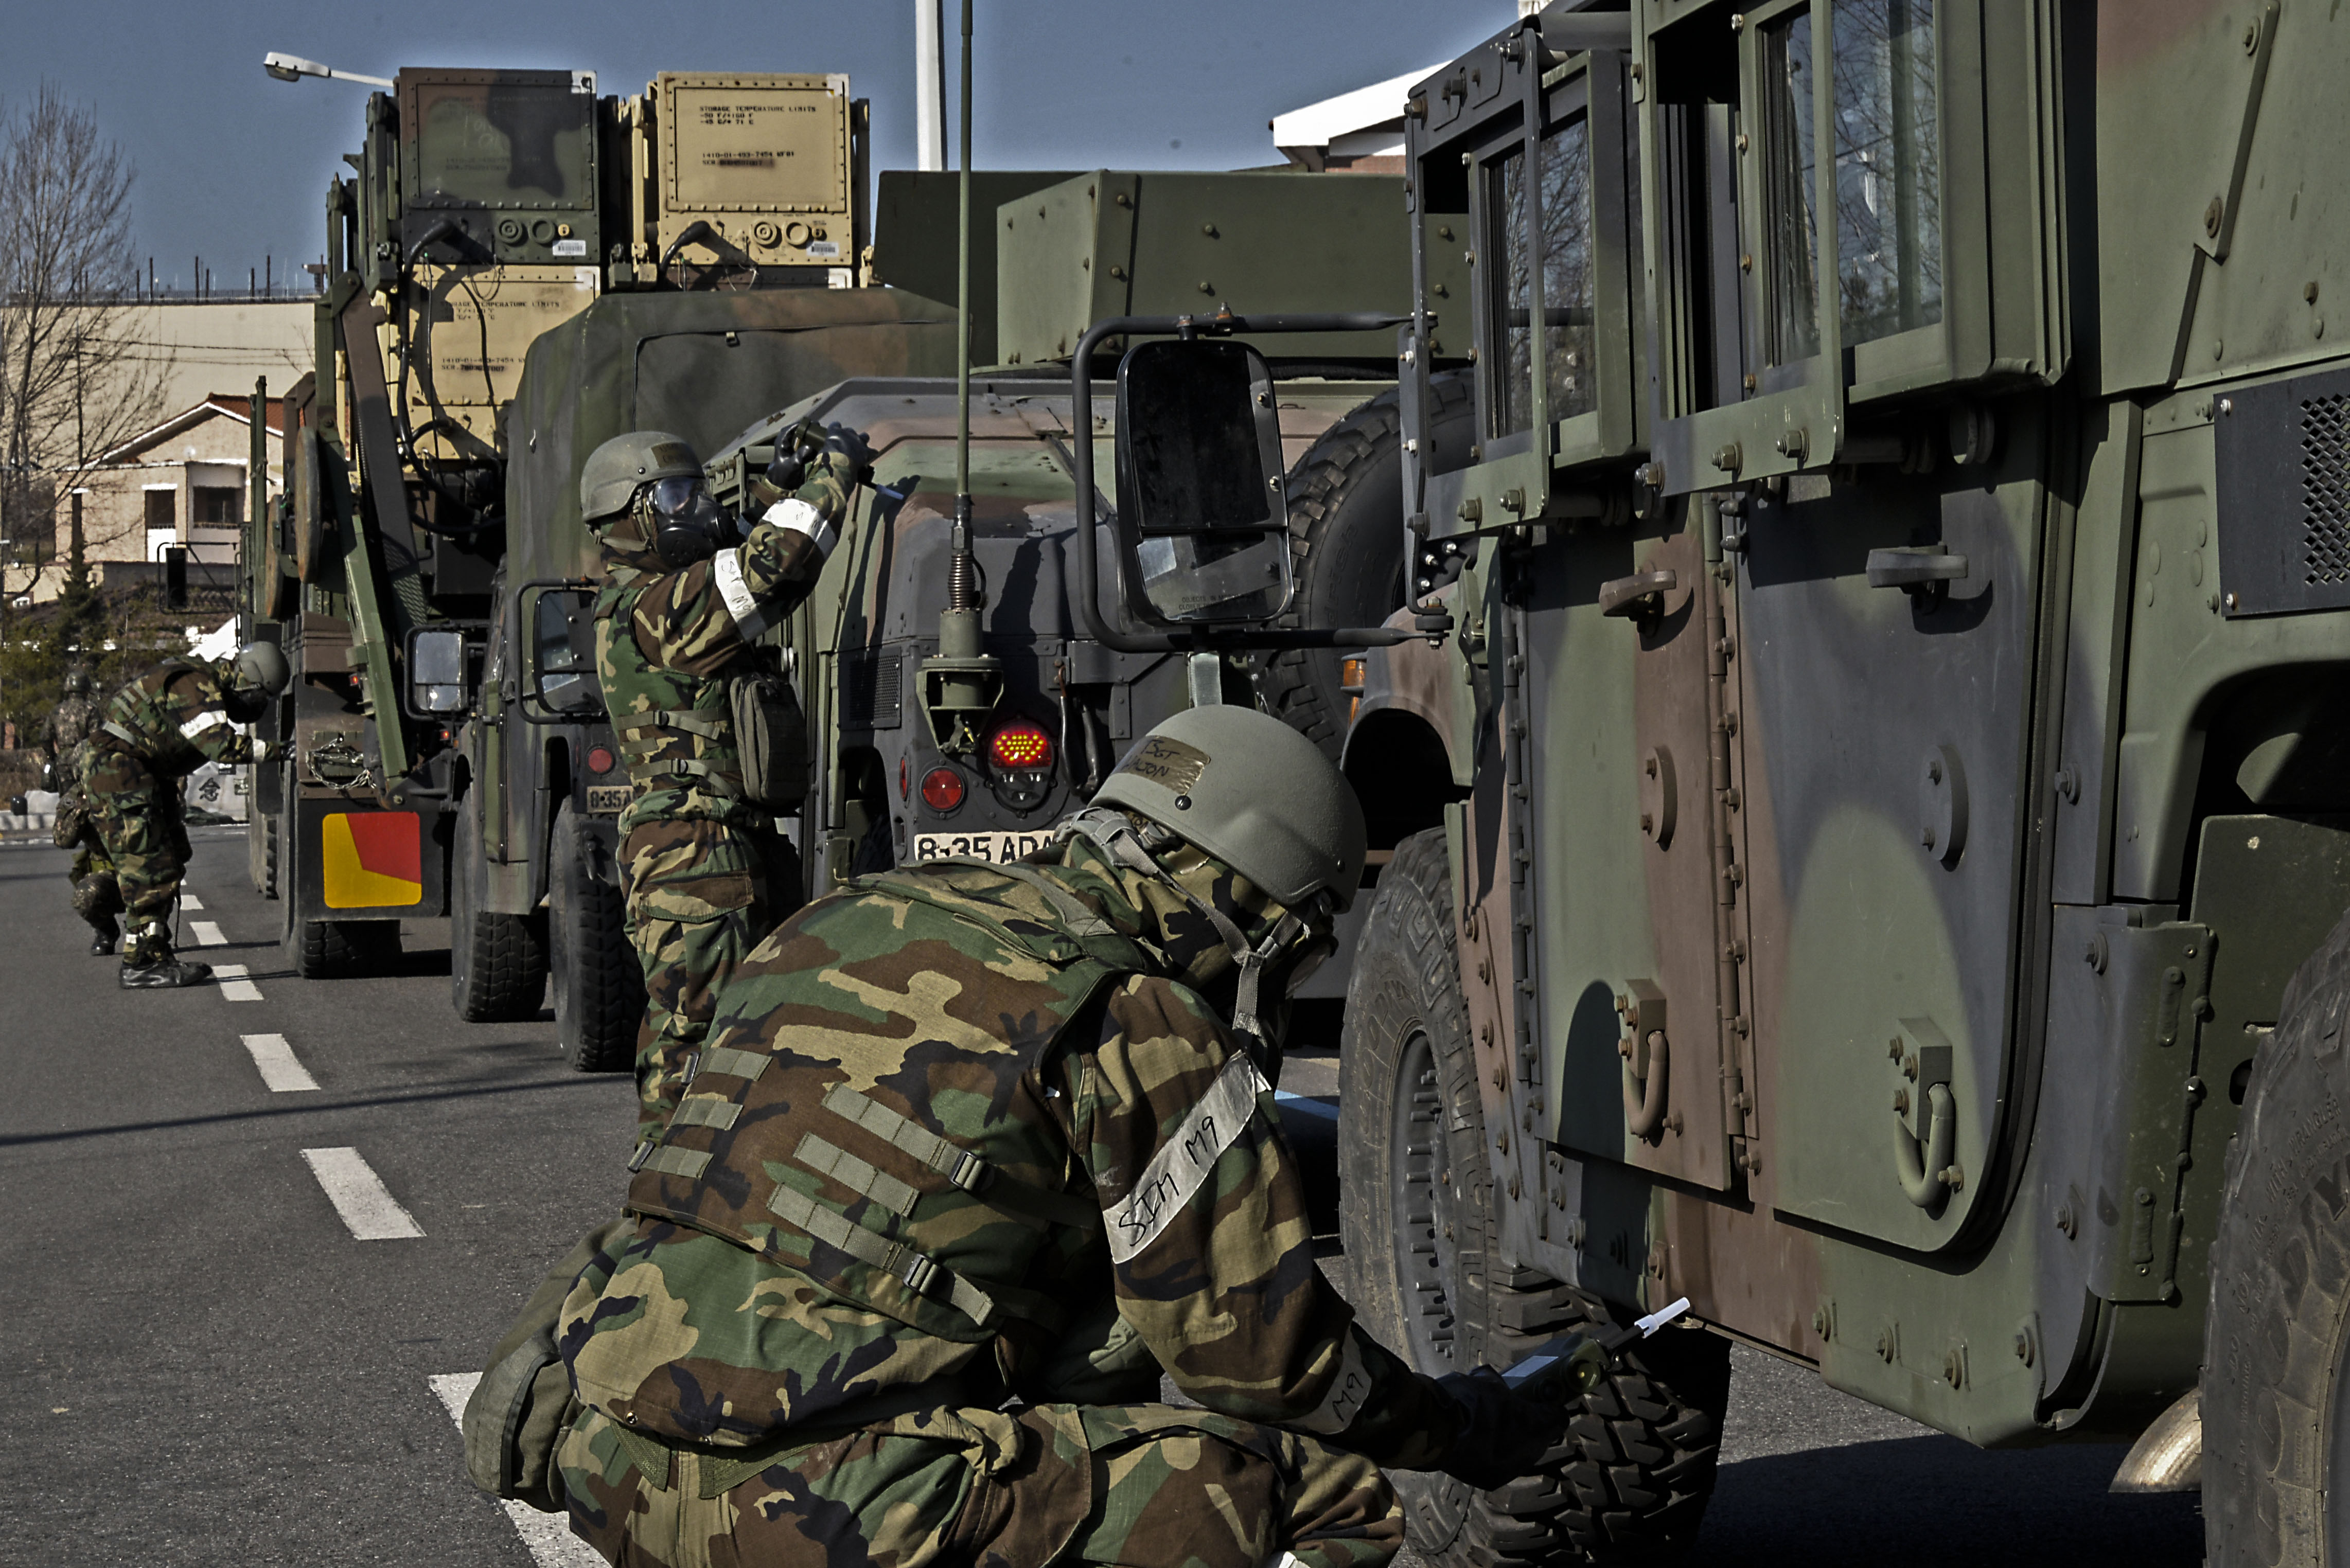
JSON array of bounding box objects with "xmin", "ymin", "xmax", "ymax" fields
[{"xmin": 0, "ymin": 830, "xmax": 2202, "ymax": 1568}]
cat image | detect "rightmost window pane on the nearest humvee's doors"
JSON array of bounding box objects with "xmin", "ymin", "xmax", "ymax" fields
[{"xmin": 1835, "ymin": 0, "xmax": 1941, "ymax": 343}]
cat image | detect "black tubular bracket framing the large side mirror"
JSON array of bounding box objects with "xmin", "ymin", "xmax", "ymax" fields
[{"xmin": 1069, "ymin": 310, "xmax": 1424, "ymax": 653}]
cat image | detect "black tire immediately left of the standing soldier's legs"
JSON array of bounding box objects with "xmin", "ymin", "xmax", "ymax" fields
[{"xmin": 547, "ymin": 801, "xmax": 644, "ymax": 1072}]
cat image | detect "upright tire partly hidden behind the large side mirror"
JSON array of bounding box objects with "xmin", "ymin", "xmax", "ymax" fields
[{"xmin": 1257, "ymin": 376, "xmax": 1471, "ymax": 762}]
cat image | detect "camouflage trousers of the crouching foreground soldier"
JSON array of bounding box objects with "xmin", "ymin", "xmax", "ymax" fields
[{"xmin": 557, "ymin": 1406, "xmax": 1403, "ymax": 1568}]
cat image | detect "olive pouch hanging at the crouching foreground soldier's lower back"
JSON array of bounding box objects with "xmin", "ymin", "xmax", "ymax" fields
[{"xmin": 461, "ymin": 1218, "xmax": 632, "ymax": 1514}]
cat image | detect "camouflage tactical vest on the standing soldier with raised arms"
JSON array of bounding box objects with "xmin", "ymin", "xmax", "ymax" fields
[{"xmin": 594, "ymin": 583, "xmax": 757, "ymax": 818}]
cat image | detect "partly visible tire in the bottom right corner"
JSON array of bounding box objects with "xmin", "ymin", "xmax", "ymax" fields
[{"xmin": 2202, "ymin": 917, "xmax": 2350, "ymax": 1568}]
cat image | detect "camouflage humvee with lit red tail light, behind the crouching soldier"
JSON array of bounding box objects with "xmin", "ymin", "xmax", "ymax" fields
[{"xmin": 662, "ymin": 169, "xmax": 1447, "ymax": 968}]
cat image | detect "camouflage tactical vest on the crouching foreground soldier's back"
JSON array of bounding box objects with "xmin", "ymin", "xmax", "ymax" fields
[{"xmin": 627, "ymin": 861, "xmax": 1154, "ymax": 1345}]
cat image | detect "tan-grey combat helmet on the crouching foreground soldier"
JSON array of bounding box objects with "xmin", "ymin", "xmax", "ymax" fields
[{"xmin": 1093, "ymin": 707, "xmax": 1365, "ymax": 910}]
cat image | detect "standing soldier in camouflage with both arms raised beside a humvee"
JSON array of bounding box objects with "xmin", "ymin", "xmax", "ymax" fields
[{"xmin": 580, "ymin": 430, "xmax": 858, "ymax": 1138}]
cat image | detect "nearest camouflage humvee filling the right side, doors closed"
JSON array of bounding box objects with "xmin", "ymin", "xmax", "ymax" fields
[{"xmin": 1062, "ymin": 0, "xmax": 2350, "ymax": 1565}]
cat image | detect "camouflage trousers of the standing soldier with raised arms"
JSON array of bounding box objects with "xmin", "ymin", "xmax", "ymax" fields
[{"xmin": 621, "ymin": 816, "xmax": 787, "ymax": 1138}]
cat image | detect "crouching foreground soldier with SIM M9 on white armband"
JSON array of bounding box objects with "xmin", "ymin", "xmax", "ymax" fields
[{"xmin": 465, "ymin": 707, "xmax": 1565, "ymax": 1568}]
